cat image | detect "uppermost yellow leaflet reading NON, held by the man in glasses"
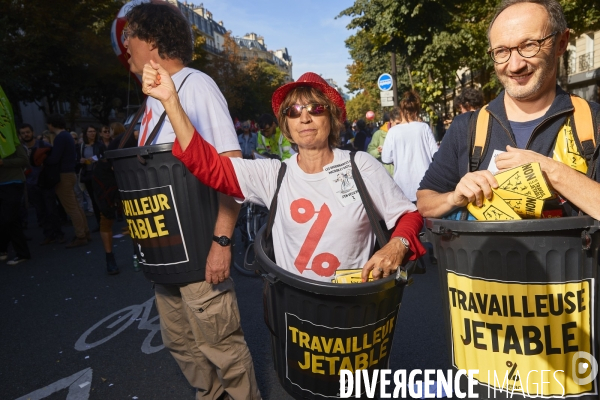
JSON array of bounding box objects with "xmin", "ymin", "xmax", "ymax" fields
[{"xmin": 495, "ymin": 163, "xmax": 552, "ymax": 200}]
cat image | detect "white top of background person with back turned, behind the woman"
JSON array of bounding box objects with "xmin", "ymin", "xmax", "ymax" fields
[{"xmin": 381, "ymin": 121, "xmax": 438, "ymax": 201}]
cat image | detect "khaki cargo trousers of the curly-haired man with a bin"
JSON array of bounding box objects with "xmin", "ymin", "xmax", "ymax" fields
[{"xmin": 155, "ymin": 278, "xmax": 260, "ymax": 400}]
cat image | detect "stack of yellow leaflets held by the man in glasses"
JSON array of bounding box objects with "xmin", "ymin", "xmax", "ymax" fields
[{"xmin": 467, "ymin": 163, "xmax": 552, "ymax": 221}]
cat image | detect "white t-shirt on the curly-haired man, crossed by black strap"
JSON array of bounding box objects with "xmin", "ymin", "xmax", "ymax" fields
[{"xmin": 138, "ymin": 67, "xmax": 240, "ymax": 153}]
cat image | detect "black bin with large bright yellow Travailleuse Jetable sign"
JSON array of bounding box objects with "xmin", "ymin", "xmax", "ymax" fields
[{"xmin": 426, "ymin": 217, "xmax": 600, "ymax": 400}]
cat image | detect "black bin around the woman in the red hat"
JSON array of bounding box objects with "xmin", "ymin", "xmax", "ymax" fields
[{"xmin": 254, "ymin": 226, "xmax": 406, "ymax": 399}]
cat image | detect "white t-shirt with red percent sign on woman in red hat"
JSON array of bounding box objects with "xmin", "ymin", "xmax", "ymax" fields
[{"xmin": 231, "ymin": 149, "xmax": 416, "ymax": 282}]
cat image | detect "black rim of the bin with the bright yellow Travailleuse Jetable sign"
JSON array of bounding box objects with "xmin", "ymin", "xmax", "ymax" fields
[{"xmin": 425, "ymin": 215, "xmax": 600, "ymax": 234}]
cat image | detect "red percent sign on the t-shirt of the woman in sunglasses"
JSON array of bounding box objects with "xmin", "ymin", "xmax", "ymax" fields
[{"xmin": 290, "ymin": 199, "xmax": 340, "ymax": 276}]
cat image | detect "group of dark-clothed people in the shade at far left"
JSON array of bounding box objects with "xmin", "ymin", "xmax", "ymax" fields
[{"xmin": 0, "ymin": 114, "xmax": 125, "ymax": 274}]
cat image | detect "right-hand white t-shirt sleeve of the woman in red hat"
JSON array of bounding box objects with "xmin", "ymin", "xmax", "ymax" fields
[{"xmin": 355, "ymin": 152, "xmax": 417, "ymax": 229}]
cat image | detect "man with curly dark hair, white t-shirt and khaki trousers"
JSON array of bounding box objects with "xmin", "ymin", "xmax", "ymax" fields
[{"xmin": 123, "ymin": 0, "xmax": 260, "ymax": 400}]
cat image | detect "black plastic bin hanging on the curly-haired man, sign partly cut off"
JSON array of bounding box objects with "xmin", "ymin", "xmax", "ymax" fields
[{"xmin": 105, "ymin": 143, "xmax": 219, "ymax": 284}]
